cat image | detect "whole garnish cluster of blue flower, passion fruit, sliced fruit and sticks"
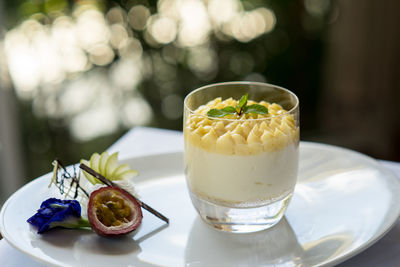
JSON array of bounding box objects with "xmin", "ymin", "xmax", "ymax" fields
[{"xmin": 28, "ymin": 152, "xmax": 169, "ymax": 236}]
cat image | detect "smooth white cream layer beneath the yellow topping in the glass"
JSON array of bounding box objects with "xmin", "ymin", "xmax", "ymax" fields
[{"xmin": 185, "ymin": 141, "xmax": 299, "ymax": 204}]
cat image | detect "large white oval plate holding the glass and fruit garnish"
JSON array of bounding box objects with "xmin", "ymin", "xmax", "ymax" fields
[{"xmin": 0, "ymin": 142, "xmax": 400, "ymax": 267}]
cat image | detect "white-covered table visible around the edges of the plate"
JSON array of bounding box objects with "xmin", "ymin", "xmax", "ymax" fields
[{"xmin": 0, "ymin": 127, "xmax": 400, "ymax": 267}]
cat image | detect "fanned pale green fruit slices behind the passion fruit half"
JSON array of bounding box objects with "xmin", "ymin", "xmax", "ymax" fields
[{"xmin": 81, "ymin": 152, "xmax": 138, "ymax": 184}]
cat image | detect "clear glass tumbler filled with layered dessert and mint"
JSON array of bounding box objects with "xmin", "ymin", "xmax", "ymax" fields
[{"xmin": 183, "ymin": 82, "xmax": 300, "ymax": 233}]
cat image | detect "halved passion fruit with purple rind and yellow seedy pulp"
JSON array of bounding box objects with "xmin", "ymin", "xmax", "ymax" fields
[{"xmin": 88, "ymin": 186, "xmax": 143, "ymax": 236}]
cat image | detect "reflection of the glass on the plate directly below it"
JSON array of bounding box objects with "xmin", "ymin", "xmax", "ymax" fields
[{"xmin": 185, "ymin": 217, "xmax": 303, "ymax": 266}]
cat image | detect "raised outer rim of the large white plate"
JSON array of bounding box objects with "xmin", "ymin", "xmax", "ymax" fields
[{"xmin": 0, "ymin": 141, "xmax": 400, "ymax": 266}]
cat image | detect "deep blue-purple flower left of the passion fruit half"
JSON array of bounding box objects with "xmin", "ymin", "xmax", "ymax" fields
[{"xmin": 28, "ymin": 198, "xmax": 90, "ymax": 234}]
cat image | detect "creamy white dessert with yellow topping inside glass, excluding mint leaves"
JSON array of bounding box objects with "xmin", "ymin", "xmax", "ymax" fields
[{"xmin": 184, "ymin": 98, "xmax": 299, "ymax": 206}]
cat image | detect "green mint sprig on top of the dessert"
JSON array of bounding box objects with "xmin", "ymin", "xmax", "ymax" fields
[{"xmin": 207, "ymin": 94, "xmax": 268, "ymax": 118}]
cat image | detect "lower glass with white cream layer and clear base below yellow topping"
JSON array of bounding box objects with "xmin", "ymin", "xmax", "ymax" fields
[{"xmin": 185, "ymin": 142, "xmax": 299, "ymax": 233}]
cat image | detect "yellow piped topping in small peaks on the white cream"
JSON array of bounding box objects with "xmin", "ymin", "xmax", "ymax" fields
[{"xmin": 184, "ymin": 98, "xmax": 299, "ymax": 155}]
